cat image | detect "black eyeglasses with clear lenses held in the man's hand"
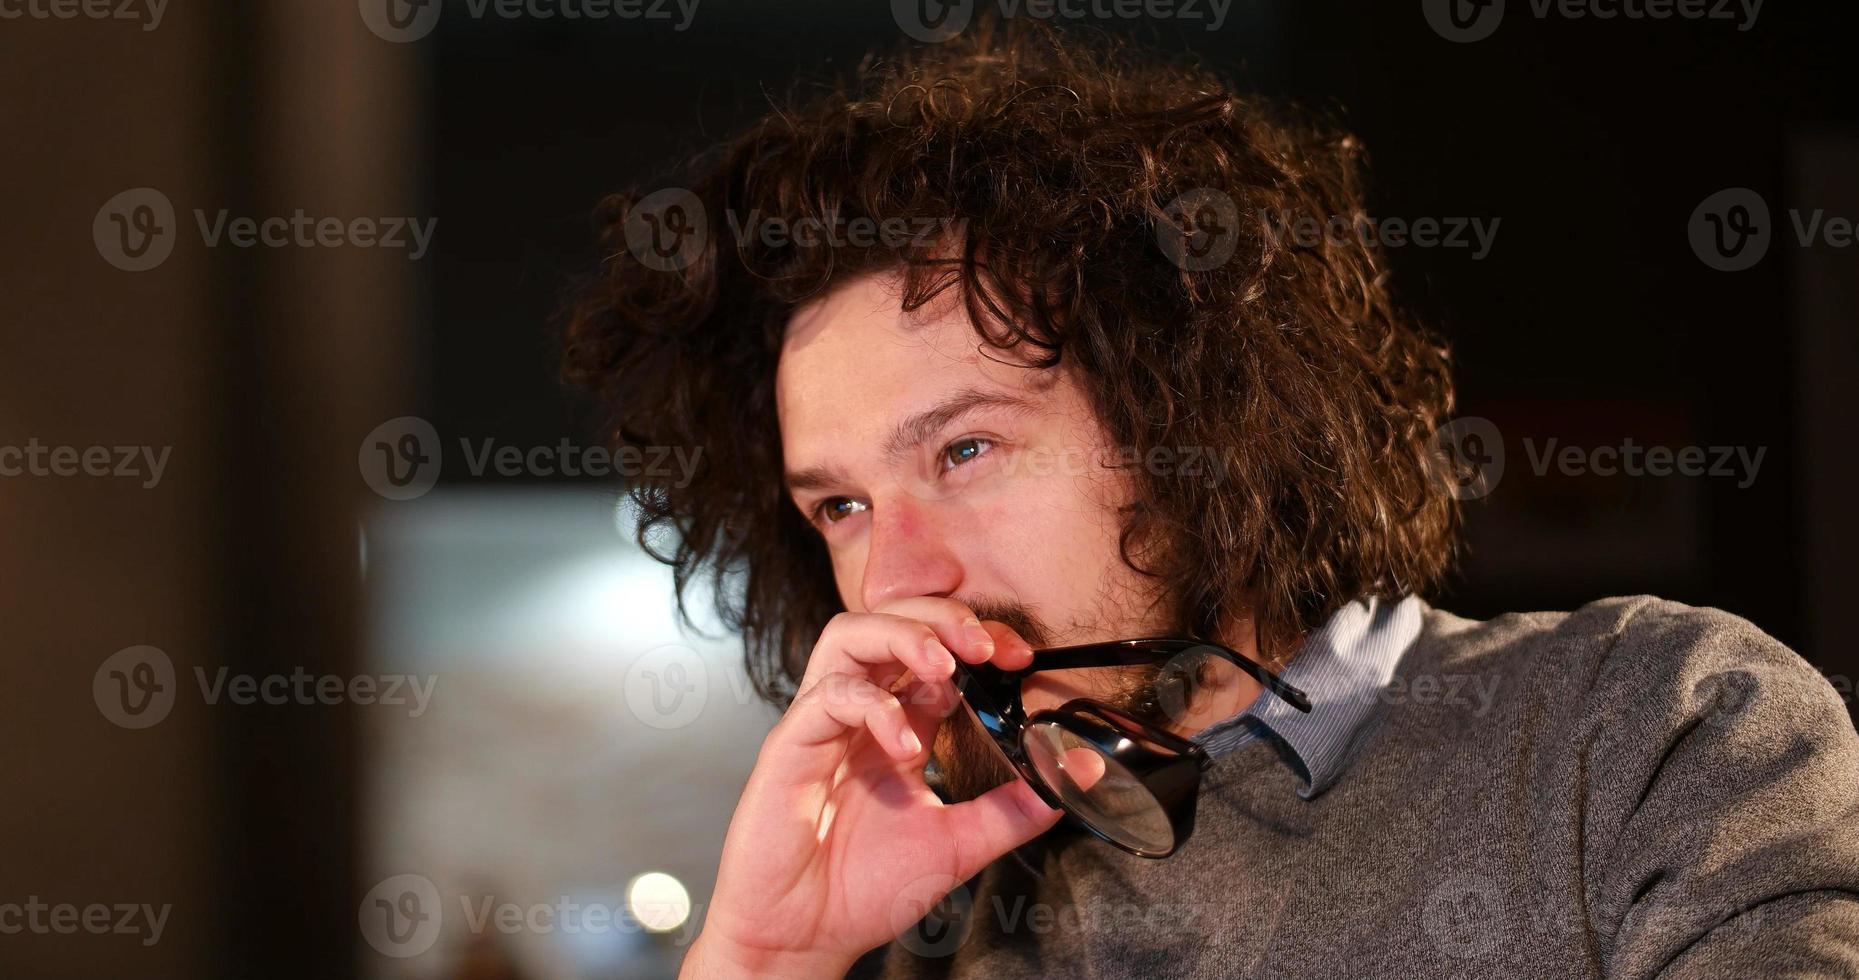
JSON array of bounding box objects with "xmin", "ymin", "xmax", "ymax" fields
[{"xmin": 956, "ymin": 636, "xmax": 1311, "ymax": 857}]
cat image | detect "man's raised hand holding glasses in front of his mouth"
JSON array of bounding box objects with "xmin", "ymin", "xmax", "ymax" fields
[{"xmin": 682, "ymin": 597, "xmax": 1060, "ymax": 978}]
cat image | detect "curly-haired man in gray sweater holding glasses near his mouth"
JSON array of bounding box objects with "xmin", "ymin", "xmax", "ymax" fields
[{"xmin": 567, "ymin": 15, "xmax": 1859, "ymax": 978}]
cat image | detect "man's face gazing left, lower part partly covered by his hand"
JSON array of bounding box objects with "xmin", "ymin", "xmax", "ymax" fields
[{"xmin": 775, "ymin": 275, "xmax": 1173, "ymax": 796}]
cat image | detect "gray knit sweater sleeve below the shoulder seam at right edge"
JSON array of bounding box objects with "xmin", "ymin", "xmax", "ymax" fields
[{"xmin": 1578, "ymin": 599, "xmax": 1859, "ymax": 980}]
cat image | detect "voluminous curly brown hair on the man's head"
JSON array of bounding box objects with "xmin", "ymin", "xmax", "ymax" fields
[{"xmin": 565, "ymin": 15, "xmax": 1459, "ymax": 703}]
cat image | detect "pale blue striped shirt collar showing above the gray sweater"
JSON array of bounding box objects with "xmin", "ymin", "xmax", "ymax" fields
[{"xmin": 1193, "ymin": 595, "xmax": 1422, "ymax": 800}]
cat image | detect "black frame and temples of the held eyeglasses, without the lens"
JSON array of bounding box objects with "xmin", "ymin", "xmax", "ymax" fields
[{"xmin": 956, "ymin": 636, "xmax": 1311, "ymax": 859}]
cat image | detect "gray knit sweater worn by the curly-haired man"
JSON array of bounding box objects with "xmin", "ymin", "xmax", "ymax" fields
[{"xmin": 853, "ymin": 597, "xmax": 1859, "ymax": 980}]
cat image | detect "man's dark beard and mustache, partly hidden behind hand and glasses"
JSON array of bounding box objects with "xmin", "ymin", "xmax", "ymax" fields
[{"xmin": 930, "ymin": 601, "xmax": 1192, "ymax": 803}]
